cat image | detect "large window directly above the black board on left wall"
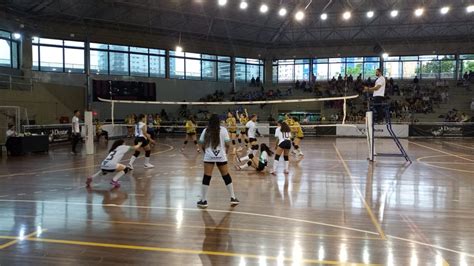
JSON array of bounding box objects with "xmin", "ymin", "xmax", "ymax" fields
[{"xmin": 90, "ymin": 43, "xmax": 166, "ymax": 77}]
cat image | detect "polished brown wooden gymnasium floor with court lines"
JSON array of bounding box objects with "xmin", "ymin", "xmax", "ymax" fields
[{"xmin": 0, "ymin": 138, "xmax": 474, "ymax": 265}]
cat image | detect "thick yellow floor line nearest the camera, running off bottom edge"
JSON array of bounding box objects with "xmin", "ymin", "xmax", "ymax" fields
[{"xmin": 2, "ymin": 237, "xmax": 381, "ymax": 266}]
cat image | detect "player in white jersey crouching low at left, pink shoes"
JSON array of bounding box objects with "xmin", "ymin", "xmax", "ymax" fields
[{"xmin": 86, "ymin": 139, "xmax": 142, "ymax": 188}]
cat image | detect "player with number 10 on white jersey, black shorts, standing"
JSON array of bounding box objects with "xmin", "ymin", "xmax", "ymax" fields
[{"xmin": 270, "ymin": 120, "xmax": 291, "ymax": 175}]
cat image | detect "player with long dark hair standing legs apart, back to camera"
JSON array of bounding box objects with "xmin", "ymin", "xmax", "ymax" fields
[{"xmin": 197, "ymin": 114, "xmax": 240, "ymax": 209}]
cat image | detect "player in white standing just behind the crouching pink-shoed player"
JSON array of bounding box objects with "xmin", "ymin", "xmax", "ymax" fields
[{"xmin": 128, "ymin": 114, "xmax": 156, "ymax": 170}]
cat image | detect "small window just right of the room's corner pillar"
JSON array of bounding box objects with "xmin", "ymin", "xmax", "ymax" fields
[{"xmin": 273, "ymin": 59, "xmax": 310, "ymax": 83}]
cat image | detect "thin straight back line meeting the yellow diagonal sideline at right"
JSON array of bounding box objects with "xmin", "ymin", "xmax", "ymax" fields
[{"xmin": 0, "ymin": 215, "xmax": 381, "ymax": 240}]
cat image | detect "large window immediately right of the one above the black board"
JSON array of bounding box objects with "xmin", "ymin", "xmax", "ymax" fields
[{"xmin": 169, "ymin": 51, "xmax": 230, "ymax": 82}]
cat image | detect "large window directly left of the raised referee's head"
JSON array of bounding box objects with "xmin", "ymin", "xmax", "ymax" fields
[{"xmin": 312, "ymin": 57, "xmax": 380, "ymax": 80}]
